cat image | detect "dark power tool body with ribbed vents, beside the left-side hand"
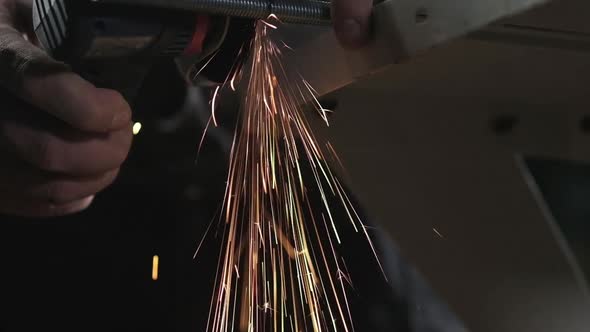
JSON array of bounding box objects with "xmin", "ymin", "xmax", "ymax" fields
[{"xmin": 33, "ymin": 0, "xmax": 196, "ymax": 103}]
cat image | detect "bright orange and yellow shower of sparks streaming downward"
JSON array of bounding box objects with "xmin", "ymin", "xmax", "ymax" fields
[{"xmin": 199, "ymin": 17, "xmax": 384, "ymax": 332}]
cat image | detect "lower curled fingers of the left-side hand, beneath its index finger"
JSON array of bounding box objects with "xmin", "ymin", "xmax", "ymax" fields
[{"xmin": 0, "ymin": 90, "xmax": 133, "ymax": 217}]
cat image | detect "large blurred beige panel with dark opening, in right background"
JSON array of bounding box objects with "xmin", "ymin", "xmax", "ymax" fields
[{"xmin": 306, "ymin": 40, "xmax": 590, "ymax": 332}]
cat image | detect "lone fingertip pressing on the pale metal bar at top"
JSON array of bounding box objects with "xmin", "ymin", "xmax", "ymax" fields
[{"xmin": 332, "ymin": 0, "xmax": 373, "ymax": 48}]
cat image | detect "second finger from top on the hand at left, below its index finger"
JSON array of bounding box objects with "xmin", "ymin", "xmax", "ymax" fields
[{"xmin": 0, "ymin": 97, "xmax": 133, "ymax": 176}]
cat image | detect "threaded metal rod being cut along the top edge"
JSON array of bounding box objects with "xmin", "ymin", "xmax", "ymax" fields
[{"xmin": 95, "ymin": 0, "xmax": 330, "ymax": 25}]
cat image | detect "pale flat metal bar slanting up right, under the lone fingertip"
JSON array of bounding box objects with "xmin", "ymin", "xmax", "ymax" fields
[{"xmin": 286, "ymin": 0, "xmax": 548, "ymax": 99}]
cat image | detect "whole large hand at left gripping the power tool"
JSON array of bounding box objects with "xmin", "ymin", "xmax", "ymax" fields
[{"xmin": 0, "ymin": 0, "xmax": 132, "ymax": 217}]
